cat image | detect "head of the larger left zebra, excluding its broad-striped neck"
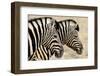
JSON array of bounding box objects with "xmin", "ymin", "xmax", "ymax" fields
[{"xmin": 44, "ymin": 19, "xmax": 64, "ymax": 58}]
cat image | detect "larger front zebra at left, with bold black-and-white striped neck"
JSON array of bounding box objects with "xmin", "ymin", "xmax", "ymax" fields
[{"xmin": 28, "ymin": 17, "xmax": 64, "ymax": 60}]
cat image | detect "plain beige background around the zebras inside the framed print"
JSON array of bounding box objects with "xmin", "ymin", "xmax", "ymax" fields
[{"xmin": 28, "ymin": 14, "xmax": 88, "ymax": 60}]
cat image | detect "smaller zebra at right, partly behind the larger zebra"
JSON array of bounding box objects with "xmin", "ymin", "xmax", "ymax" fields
[{"xmin": 56, "ymin": 19, "xmax": 83, "ymax": 54}]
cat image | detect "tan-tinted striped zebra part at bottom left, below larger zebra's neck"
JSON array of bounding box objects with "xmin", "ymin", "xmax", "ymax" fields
[{"xmin": 30, "ymin": 45, "xmax": 53, "ymax": 61}]
